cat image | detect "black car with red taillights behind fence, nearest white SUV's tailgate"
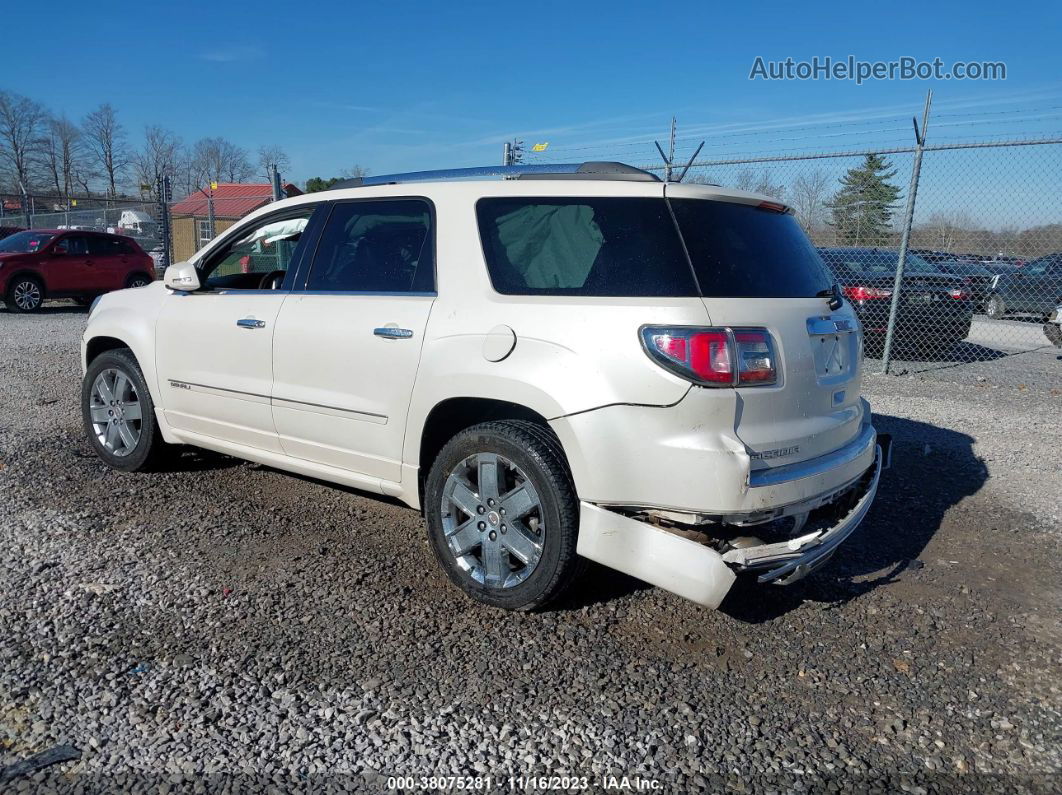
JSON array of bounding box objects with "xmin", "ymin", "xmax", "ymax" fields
[{"xmin": 819, "ymin": 248, "xmax": 974, "ymax": 356}]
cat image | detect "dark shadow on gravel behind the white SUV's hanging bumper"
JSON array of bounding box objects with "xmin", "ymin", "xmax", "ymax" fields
[{"xmin": 720, "ymin": 415, "xmax": 988, "ymax": 623}]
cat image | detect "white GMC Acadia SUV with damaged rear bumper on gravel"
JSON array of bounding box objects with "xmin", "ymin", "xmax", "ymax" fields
[{"xmin": 82, "ymin": 163, "xmax": 889, "ymax": 609}]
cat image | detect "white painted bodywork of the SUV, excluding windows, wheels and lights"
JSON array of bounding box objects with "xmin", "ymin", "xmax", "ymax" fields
[{"xmin": 83, "ymin": 180, "xmax": 874, "ymax": 606}]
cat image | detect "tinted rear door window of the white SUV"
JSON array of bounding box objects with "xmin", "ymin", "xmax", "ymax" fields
[{"xmin": 306, "ymin": 198, "xmax": 434, "ymax": 293}]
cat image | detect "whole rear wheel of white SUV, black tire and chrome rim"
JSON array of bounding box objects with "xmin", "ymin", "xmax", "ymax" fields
[{"xmin": 425, "ymin": 420, "xmax": 582, "ymax": 610}]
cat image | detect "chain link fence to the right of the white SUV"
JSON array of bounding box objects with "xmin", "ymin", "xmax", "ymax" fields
[{"xmin": 628, "ymin": 140, "xmax": 1062, "ymax": 368}]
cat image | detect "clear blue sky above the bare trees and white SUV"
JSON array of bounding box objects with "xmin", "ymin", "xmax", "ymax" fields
[{"xmin": 0, "ymin": 0, "xmax": 1062, "ymax": 187}]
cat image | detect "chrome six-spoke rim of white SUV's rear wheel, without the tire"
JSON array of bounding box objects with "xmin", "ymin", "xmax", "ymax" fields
[{"xmin": 442, "ymin": 453, "xmax": 546, "ymax": 588}]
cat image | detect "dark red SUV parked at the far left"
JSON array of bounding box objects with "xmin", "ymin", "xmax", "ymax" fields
[{"xmin": 0, "ymin": 229, "xmax": 155, "ymax": 312}]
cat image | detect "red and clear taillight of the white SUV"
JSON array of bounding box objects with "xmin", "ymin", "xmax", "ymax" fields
[{"xmin": 641, "ymin": 326, "xmax": 777, "ymax": 386}]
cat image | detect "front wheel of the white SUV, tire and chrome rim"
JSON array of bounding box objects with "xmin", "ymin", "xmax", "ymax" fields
[{"xmin": 81, "ymin": 348, "xmax": 169, "ymax": 472}]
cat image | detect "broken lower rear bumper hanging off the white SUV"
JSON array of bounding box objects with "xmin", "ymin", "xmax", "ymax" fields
[{"xmin": 577, "ymin": 434, "xmax": 891, "ymax": 608}]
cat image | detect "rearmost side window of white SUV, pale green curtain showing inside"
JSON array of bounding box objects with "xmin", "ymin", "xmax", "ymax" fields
[{"xmin": 476, "ymin": 197, "xmax": 698, "ymax": 297}]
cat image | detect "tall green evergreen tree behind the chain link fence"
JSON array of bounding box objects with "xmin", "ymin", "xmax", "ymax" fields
[{"xmin": 830, "ymin": 155, "xmax": 900, "ymax": 245}]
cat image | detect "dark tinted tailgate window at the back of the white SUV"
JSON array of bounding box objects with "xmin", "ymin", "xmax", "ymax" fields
[{"xmin": 671, "ymin": 198, "xmax": 834, "ymax": 298}]
